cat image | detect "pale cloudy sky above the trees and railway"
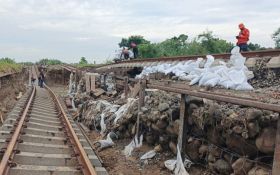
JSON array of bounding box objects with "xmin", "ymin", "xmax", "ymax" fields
[{"xmin": 0, "ymin": 0, "xmax": 280, "ymax": 63}]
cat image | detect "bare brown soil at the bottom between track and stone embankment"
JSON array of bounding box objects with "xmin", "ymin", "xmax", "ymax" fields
[{"xmin": 89, "ymin": 131, "xmax": 174, "ymax": 175}]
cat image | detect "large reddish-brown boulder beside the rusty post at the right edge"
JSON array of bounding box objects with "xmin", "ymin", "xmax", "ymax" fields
[{"xmin": 256, "ymin": 127, "xmax": 276, "ymax": 154}]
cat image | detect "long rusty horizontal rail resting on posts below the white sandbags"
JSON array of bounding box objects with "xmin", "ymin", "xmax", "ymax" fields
[{"xmin": 147, "ymin": 84, "xmax": 280, "ymax": 112}]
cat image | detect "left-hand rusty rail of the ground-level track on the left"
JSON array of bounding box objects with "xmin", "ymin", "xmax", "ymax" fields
[{"xmin": 0, "ymin": 86, "xmax": 36, "ymax": 175}]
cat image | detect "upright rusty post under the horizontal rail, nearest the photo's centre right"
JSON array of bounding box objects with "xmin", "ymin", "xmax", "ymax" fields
[{"xmin": 178, "ymin": 94, "xmax": 189, "ymax": 160}]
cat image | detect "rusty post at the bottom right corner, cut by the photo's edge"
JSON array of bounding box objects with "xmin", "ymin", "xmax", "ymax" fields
[{"xmin": 272, "ymin": 115, "xmax": 280, "ymax": 175}]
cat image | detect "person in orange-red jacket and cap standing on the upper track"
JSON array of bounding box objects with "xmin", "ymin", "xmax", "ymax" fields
[{"xmin": 236, "ymin": 23, "xmax": 250, "ymax": 52}]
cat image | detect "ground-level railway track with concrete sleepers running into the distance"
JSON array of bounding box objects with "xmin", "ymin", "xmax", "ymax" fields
[{"xmin": 0, "ymin": 66, "xmax": 107, "ymax": 175}]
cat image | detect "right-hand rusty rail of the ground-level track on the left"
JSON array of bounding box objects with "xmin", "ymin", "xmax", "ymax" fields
[{"xmin": 45, "ymin": 85, "xmax": 96, "ymax": 175}]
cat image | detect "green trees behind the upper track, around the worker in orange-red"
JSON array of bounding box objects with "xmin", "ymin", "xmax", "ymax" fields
[{"xmin": 119, "ymin": 30, "xmax": 265, "ymax": 58}]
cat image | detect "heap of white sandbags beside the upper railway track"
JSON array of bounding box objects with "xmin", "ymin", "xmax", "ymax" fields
[{"xmin": 136, "ymin": 47, "xmax": 254, "ymax": 90}]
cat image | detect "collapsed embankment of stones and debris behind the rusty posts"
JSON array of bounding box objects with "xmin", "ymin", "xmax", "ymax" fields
[{"xmin": 69, "ymin": 54, "xmax": 280, "ymax": 175}]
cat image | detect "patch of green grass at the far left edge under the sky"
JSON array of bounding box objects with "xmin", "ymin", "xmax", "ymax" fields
[{"xmin": 0, "ymin": 58, "xmax": 22, "ymax": 73}]
